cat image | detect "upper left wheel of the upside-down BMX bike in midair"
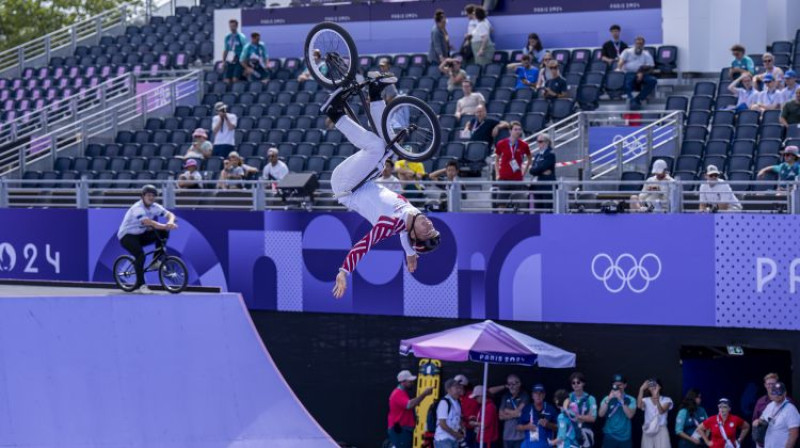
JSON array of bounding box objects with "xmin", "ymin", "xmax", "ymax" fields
[{"xmin": 303, "ymin": 22, "xmax": 358, "ymax": 89}]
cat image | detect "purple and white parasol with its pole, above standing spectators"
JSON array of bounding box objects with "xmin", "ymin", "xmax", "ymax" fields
[{"xmin": 400, "ymin": 320, "xmax": 575, "ymax": 448}]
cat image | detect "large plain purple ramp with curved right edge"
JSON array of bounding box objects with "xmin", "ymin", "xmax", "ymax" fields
[{"xmin": 0, "ymin": 292, "xmax": 337, "ymax": 448}]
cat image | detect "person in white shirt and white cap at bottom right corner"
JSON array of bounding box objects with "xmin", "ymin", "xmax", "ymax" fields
[{"xmin": 753, "ymin": 383, "xmax": 800, "ymax": 448}]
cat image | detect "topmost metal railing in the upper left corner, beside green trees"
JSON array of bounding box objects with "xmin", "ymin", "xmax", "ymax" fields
[{"xmin": 0, "ymin": 3, "xmax": 134, "ymax": 76}]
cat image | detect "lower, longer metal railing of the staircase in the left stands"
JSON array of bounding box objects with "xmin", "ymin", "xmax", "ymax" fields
[{"xmin": 0, "ymin": 70, "xmax": 203, "ymax": 176}]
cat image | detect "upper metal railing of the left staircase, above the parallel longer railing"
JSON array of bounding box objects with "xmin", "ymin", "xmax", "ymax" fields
[{"xmin": 0, "ymin": 73, "xmax": 136, "ymax": 145}]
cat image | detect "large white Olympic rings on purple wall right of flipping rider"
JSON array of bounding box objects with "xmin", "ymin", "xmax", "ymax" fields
[{"xmin": 592, "ymin": 253, "xmax": 661, "ymax": 294}]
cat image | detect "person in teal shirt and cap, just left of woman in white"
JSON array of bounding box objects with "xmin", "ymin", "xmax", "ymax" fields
[{"xmin": 597, "ymin": 374, "xmax": 636, "ymax": 448}]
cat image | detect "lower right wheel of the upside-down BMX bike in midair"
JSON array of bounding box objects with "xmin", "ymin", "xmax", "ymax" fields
[{"xmin": 381, "ymin": 96, "xmax": 442, "ymax": 162}]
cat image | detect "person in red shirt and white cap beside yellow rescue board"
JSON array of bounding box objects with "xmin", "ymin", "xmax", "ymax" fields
[{"xmin": 388, "ymin": 370, "xmax": 433, "ymax": 448}]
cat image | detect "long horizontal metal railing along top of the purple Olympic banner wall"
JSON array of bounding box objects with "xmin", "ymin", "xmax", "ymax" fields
[{"xmin": 0, "ymin": 179, "xmax": 800, "ymax": 214}]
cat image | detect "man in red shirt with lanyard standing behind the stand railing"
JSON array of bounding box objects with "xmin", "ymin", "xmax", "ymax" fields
[{"xmin": 494, "ymin": 121, "xmax": 532, "ymax": 213}]
